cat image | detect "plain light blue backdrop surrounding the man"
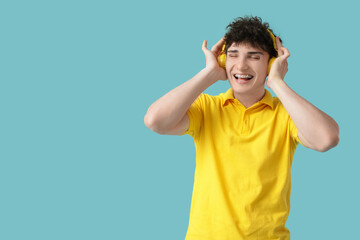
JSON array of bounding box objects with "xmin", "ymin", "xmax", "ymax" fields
[{"xmin": 0, "ymin": 0, "xmax": 360, "ymax": 240}]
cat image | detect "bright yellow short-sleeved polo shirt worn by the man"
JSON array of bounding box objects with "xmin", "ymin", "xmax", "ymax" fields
[{"xmin": 183, "ymin": 88, "xmax": 302, "ymax": 240}]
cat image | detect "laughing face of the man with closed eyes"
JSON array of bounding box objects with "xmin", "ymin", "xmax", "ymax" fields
[{"xmin": 226, "ymin": 43, "xmax": 269, "ymax": 97}]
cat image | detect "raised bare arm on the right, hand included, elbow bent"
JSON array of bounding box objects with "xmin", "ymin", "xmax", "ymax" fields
[{"xmin": 267, "ymin": 38, "xmax": 339, "ymax": 152}]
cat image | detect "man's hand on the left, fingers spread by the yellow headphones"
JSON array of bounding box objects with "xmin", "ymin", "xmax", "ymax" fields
[{"xmin": 202, "ymin": 37, "xmax": 227, "ymax": 81}]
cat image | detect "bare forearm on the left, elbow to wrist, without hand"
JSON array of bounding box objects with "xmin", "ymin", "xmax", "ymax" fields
[{"xmin": 144, "ymin": 68, "xmax": 218, "ymax": 130}]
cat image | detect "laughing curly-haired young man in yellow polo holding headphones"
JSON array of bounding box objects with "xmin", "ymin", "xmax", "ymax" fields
[{"xmin": 144, "ymin": 17, "xmax": 339, "ymax": 240}]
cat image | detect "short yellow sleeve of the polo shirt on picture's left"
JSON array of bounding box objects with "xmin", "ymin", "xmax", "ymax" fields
[{"xmin": 182, "ymin": 93, "xmax": 206, "ymax": 138}]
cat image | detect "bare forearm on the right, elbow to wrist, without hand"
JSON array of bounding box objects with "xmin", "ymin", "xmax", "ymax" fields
[{"xmin": 271, "ymin": 80, "xmax": 339, "ymax": 150}]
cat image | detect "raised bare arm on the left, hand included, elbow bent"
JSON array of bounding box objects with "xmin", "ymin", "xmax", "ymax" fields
[{"xmin": 144, "ymin": 38, "xmax": 227, "ymax": 135}]
